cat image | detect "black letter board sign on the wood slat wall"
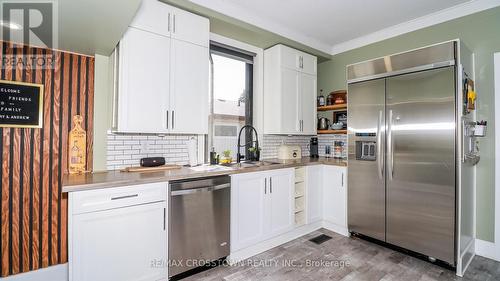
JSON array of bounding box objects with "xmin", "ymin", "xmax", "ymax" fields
[{"xmin": 0, "ymin": 80, "xmax": 43, "ymax": 128}]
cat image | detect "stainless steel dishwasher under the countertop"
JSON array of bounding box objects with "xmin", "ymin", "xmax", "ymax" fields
[{"xmin": 168, "ymin": 176, "xmax": 231, "ymax": 277}]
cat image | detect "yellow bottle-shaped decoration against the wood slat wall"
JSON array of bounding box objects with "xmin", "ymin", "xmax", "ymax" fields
[{"xmin": 68, "ymin": 115, "xmax": 87, "ymax": 174}]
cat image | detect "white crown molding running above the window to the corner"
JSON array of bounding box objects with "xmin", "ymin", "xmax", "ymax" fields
[{"xmin": 190, "ymin": 0, "xmax": 332, "ymax": 54}]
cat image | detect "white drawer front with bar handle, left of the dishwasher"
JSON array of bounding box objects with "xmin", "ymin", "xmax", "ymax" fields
[{"xmin": 70, "ymin": 180, "xmax": 167, "ymax": 214}]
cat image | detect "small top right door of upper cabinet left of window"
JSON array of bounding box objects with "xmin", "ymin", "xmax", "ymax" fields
[{"xmin": 171, "ymin": 7, "xmax": 210, "ymax": 48}]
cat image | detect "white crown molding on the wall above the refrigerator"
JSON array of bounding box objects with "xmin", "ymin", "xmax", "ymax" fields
[{"xmin": 329, "ymin": 0, "xmax": 500, "ymax": 55}]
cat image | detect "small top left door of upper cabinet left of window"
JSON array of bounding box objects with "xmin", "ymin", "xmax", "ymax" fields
[{"xmin": 130, "ymin": 0, "xmax": 172, "ymax": 36}]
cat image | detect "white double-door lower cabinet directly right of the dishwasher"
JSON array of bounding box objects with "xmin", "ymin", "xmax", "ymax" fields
[{"xmin": 231, "ymin": 169, "xmax": 294, "ymax": 252}]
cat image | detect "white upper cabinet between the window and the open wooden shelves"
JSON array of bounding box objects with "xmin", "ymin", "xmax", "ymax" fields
[{"xmin": 264, "ymin": 45, "xmax": 317, "ymax": 135}]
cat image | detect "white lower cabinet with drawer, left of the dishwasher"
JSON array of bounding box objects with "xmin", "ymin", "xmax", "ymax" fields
[{"xmin": 69, "ymin": 183, "xmax": 168, "ymax": 281}]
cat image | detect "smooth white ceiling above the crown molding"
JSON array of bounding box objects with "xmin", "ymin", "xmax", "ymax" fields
[{"xmin": 191, "ymin": 0, "xmax": 500, "ymax": 54}]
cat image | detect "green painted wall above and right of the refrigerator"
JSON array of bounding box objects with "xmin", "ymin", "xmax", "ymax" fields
[{"xmin": 318, "ymin": 8, "xmax": 500, "ymax": 241}]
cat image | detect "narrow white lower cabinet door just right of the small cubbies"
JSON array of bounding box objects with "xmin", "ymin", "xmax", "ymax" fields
[{"xmin": 306, "ymin": 165, "xmax": 323, "ymax": 223}]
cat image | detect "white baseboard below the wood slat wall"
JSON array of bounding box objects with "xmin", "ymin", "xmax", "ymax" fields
[{"xmin": 0, "ymin": 263, "xmax": 68, "ymax": 281}]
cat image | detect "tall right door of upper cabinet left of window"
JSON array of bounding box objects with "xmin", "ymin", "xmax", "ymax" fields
[{"xmin": 170, "ymin": 39, "xmax": 209, "ymax": 135}]
